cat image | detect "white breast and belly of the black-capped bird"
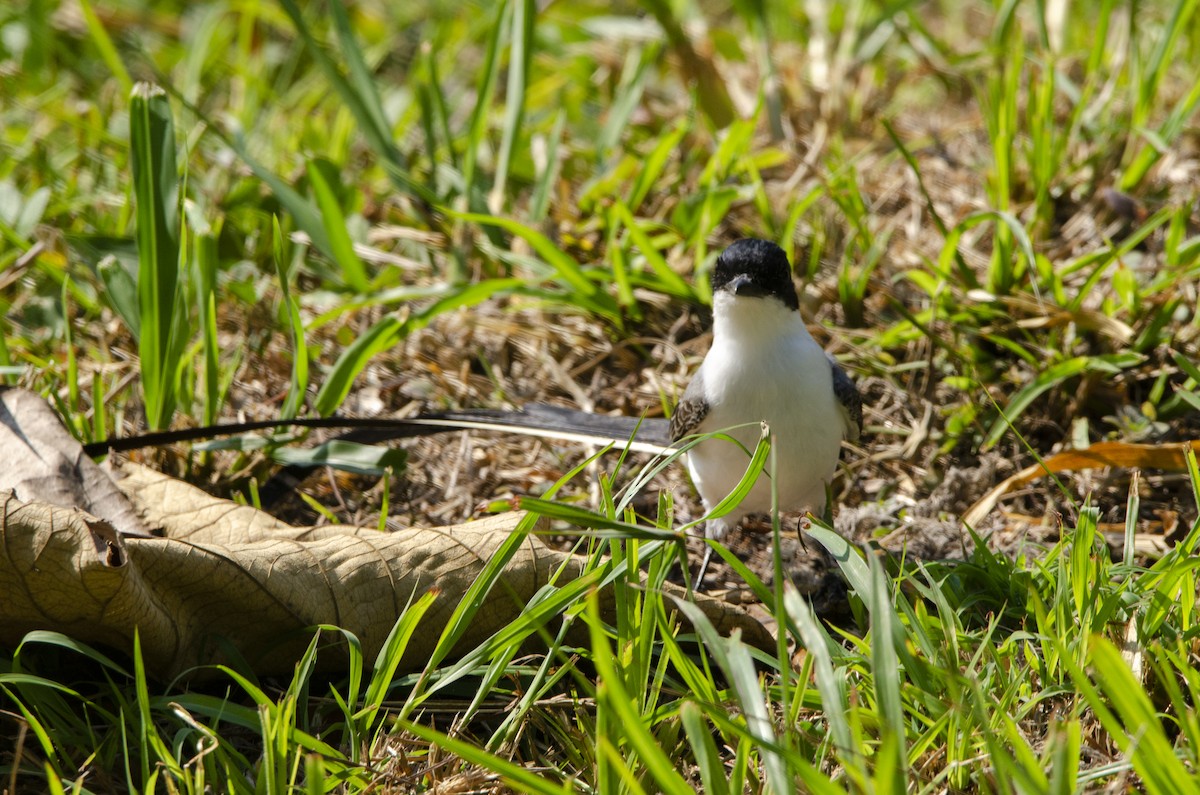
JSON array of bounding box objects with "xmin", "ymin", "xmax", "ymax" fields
[{"xmin": 688, "ymin": 294, "xmax": 845, "ymax": 534}]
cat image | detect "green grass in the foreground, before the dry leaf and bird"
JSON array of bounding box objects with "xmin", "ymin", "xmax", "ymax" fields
[{"xmin": 9, "ymin": 461, "xmax": 1200, "ymax": 793}]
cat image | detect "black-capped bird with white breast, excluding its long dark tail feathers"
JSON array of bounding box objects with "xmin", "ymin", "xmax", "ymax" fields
[{"xmin": 670, "ymin": 238, "xmax": 863, "ymax": 590}]
